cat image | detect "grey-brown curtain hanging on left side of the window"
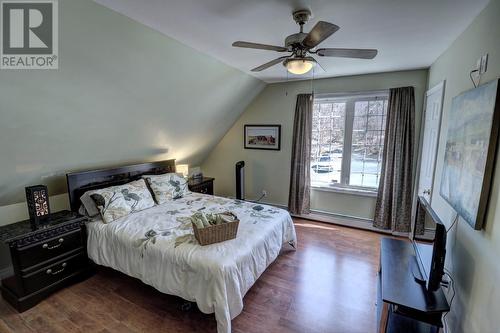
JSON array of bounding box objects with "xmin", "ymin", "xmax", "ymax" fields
[{"xmin": 288, "ymin": 94, "xmax": 313, "ymax": 215}]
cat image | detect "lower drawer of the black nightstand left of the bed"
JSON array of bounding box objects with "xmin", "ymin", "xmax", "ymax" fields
[{"xmin": 21, "ymin": 252, "xmax": 88, "ymax": 293}]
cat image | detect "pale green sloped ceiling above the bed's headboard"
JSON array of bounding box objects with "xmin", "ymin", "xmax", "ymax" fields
[{"xmin": 0, "ymin": 0, "xmax": 265, "ymax": 206}]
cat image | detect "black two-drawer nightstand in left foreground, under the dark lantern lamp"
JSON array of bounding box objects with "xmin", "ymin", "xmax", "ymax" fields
[{"xmin": 0, "ymin": 211, "xmax": 92, "ymax": 312}]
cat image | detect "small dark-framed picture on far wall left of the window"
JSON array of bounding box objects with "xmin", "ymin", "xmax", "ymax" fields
[{"xmin": 244, "ymin": 125, "xmax": 281, "ymax": 150}]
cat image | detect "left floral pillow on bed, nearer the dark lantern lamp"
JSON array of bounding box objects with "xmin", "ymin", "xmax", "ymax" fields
[{"xmin": 89, "ymin": 179, "xmax": 155, "ymax": 223}]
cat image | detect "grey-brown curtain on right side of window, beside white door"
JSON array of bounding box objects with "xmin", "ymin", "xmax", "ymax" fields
[{"xmin": 373, "ymin": 87, "xmax": 415, "ymax": 232}]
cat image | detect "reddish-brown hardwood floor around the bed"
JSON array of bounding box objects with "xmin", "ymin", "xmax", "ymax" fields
[{"xmin": 0, "ymin": 219, "xmax": 381, "ymax": 333}]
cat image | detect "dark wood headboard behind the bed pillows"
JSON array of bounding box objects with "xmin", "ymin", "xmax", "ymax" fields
[{"xmin": 66, "ymin": 160, "xmax": 175, "ymax": 212}]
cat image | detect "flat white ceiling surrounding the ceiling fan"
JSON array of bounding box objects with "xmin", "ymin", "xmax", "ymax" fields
[{"xmin": 95, "ymin": 0, "xmax": 488, "ymax": 82}]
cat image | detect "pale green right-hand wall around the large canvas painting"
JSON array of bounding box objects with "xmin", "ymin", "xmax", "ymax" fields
[{"xmin": 429, "ymin": 0, "xmax": 500, "ymax": 333}]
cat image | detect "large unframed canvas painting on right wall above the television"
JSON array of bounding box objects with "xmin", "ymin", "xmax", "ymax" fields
[{"xmin": 440, "ymin": 80, "xmax": 500, "ymax": 230}]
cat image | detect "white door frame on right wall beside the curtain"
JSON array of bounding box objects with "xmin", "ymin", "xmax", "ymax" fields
[{"xmin": 410, "ymin": 80, "xmax": 446, "ymax": 238}]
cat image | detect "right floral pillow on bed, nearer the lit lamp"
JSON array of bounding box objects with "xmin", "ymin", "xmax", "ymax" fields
[{"xmin": 142, "ymin": 173, "xmax": 189, "ymax": 205}]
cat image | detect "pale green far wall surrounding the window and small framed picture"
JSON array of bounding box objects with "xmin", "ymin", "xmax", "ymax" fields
[{"xmin": 202, "ymin": 70, "xmax": 427, "ymax": 219}]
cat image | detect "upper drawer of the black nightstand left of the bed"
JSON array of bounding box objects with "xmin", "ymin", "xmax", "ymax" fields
[{"xmin": 13, "ymin": 229, "xmax": 83, "ymax": 270}]
